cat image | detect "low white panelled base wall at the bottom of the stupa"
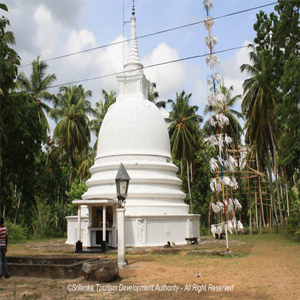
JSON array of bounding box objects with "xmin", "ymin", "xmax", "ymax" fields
[{"xmin": 66, "ymin": 211, "xmax": 200, "ymax": 247}]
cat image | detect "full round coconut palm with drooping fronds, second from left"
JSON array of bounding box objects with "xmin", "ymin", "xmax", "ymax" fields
[{"xmin": 50, "ymin": 85, "xmax": 94, "ymax": 173}]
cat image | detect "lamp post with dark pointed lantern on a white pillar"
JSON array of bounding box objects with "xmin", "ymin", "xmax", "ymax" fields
[{"xmin": 116, "ymin": 163, "xmax": 130, "ymax": 268}]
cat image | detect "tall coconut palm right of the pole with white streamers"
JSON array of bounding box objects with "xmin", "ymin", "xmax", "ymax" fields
[{"xmin": 241, "ymin": 45, "xmax": 284, "ymax": 226}]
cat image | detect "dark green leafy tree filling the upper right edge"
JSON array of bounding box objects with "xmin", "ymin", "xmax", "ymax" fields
[{"xmin": 254, "ymin": 0, "xmax": 300, "ymax": 176}]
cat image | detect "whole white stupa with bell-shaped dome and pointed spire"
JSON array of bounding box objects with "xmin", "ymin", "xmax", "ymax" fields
[{"xmin": 67, "ymin": 8, "xmax": 200, "ymax": 247}]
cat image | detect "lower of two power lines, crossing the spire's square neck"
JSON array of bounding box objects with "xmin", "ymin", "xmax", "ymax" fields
[{"xmin": 41, "ymin": 46, "xmax": 248, "ymax": 89}]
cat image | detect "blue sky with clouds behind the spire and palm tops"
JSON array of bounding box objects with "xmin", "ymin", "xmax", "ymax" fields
[{"xmin": 1, "ymin": 0, "xmax": 274, "ymax": 134}]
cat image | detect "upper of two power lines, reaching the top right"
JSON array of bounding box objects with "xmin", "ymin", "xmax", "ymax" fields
[{"xmin": 19, "ymin": 2, "xmax": 277, "ymax": 68}]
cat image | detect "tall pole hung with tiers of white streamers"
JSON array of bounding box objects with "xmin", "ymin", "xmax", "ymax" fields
[{"xmin": 203, "ymin": 0, "xmax": 241, "ymax": 252}]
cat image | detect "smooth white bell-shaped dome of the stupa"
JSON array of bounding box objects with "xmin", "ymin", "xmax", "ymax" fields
[{"xmin": 97, "ymin": 98, "xmax": 171, "ymax": 158}]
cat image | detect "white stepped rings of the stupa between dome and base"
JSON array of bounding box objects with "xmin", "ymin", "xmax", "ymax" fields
[{"xmin": 82, "ymin": 159, "xmax": 188, "ymax": 215}]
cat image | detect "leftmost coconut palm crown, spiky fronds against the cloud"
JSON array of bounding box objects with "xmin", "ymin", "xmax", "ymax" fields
[{"xmin": 17, "ymin": 56, "xmax": 56, "ymax": 130}]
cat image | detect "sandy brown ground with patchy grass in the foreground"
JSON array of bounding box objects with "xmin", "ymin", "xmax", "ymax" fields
[{"xmin": 0, "ymin": 235, "xmax": 300, "ymax": 299}]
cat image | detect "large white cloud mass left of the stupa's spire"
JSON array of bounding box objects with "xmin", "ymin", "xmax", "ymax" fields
[{"xmin": 16, "ymin": 5, "xmax": 128, "ymax": 132}]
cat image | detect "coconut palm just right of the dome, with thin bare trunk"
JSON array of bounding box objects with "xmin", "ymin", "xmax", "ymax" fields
[{"xmin": 167, "ymin": 91, "xmax": 202, "ymax": 210}]
